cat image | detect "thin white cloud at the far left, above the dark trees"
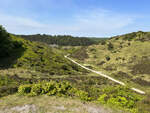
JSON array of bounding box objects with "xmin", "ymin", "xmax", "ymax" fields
[{"xmin": 0, "ymin": 14, "xmax": 44, "ymax": 33}]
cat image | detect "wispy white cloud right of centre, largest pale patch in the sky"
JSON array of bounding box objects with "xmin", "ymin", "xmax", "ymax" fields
[{"xmin": 71, "ymin": 10, "xmax": 135, "ymax": 36}]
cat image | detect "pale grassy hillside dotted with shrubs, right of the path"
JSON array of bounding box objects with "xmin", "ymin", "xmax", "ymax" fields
[{"xmin": 72, "ymin": 31, "xmax": 150, "ymax": 91}]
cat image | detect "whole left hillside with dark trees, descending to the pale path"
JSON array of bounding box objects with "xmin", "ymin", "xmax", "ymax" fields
[{"xmin": 0, "ymin": 27, "xmax": 87, "ymax": 97}]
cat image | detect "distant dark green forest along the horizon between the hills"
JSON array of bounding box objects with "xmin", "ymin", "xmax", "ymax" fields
[{"xmin": 17, "ymin": 34, "xmax": 97, "ymax": 46}]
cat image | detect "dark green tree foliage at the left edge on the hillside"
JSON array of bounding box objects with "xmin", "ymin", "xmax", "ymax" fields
[{"xmin": 0, "ymin": 26, "xmax": 25, "ymax": 66}]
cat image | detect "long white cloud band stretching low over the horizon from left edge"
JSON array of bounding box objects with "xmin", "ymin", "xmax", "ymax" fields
[{"xmin": 0, "ymin": 9, "xmax": 135, "ymax": 36}]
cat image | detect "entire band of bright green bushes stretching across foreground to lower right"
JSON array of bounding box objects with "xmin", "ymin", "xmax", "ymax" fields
[{"xmin": 18, "ymin": 81, "xmax": 142, "ymax": 113}]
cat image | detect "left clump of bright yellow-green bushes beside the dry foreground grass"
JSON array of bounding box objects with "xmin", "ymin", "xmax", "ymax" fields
[{"xmin": 18, "ymin": 81, "xmax": 72, "ymax": 96}]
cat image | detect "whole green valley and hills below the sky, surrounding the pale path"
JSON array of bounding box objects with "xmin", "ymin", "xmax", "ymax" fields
[{"xmin": 0, "ymin": 27, "xmax": 150, "ymax": 113}]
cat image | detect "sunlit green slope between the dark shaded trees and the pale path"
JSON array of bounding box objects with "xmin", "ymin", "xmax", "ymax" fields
[{"xmin": 9, "ymin": 37, "xmax": 85, "ymax": 75}]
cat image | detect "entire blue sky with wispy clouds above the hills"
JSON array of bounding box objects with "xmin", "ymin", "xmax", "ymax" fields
[{"xmin": 0, "ymin": 0, "xmax": 150, "ymax": 37}]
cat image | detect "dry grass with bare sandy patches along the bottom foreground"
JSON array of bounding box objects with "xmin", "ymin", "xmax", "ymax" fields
[{"xmin": 0, "ymin": 95, "xmax": 125, "ymax": 113}]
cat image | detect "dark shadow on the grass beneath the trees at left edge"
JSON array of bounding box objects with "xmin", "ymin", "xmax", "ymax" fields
[{"xmin": 0, "ymin": 42, "xmax": 26, "ymax": 69}]
